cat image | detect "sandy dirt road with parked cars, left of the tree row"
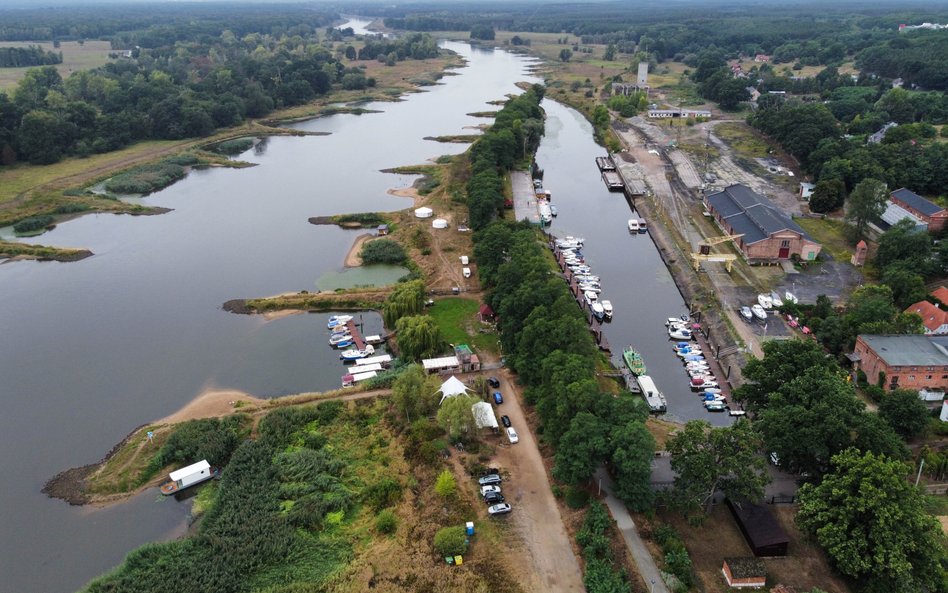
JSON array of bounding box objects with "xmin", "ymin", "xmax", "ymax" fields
[{"xmin": 488, "ymin": 370, "xmax": 585, "ymax": 592}]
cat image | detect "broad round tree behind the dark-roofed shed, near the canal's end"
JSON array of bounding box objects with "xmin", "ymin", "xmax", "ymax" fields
[{"xmin": 667, "ymin": 419, "xmax": 769, "ymax": 514}]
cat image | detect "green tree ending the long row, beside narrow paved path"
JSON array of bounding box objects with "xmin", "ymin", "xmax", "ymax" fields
[{"xmin": 608, "ymin": 420, "xmax": 655, "ymax": 512}]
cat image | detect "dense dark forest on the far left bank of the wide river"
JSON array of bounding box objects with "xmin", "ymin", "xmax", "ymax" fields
[{"xmin": 0, "ymin": 8, "xmax": 438, "ymax": 165}]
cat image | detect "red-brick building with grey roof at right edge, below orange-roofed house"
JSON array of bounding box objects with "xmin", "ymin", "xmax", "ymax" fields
[{"xmin": 850, "ymin": 335, "xmax": 948, "ymax": 391}]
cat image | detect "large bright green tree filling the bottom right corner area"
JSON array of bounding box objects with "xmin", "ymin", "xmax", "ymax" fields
[{"xmin": 797, "ymin": 449, "xmax": 946, "ymax": 593}]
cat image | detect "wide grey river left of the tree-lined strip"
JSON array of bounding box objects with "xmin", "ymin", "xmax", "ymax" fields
[{"xmin": 0, "ymin": 21, "xmax": 534, "ymax": 593}]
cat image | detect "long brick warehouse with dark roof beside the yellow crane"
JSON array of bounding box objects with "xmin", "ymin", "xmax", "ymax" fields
[{"xmin": 705, "ymin": 184, "xmax": 821, "ymax": 262}]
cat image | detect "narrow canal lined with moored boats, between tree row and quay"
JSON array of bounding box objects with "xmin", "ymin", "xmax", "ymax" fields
[{"xmin": 536, "ymin": 99, "xmax": 731, "ymax": 426}]
